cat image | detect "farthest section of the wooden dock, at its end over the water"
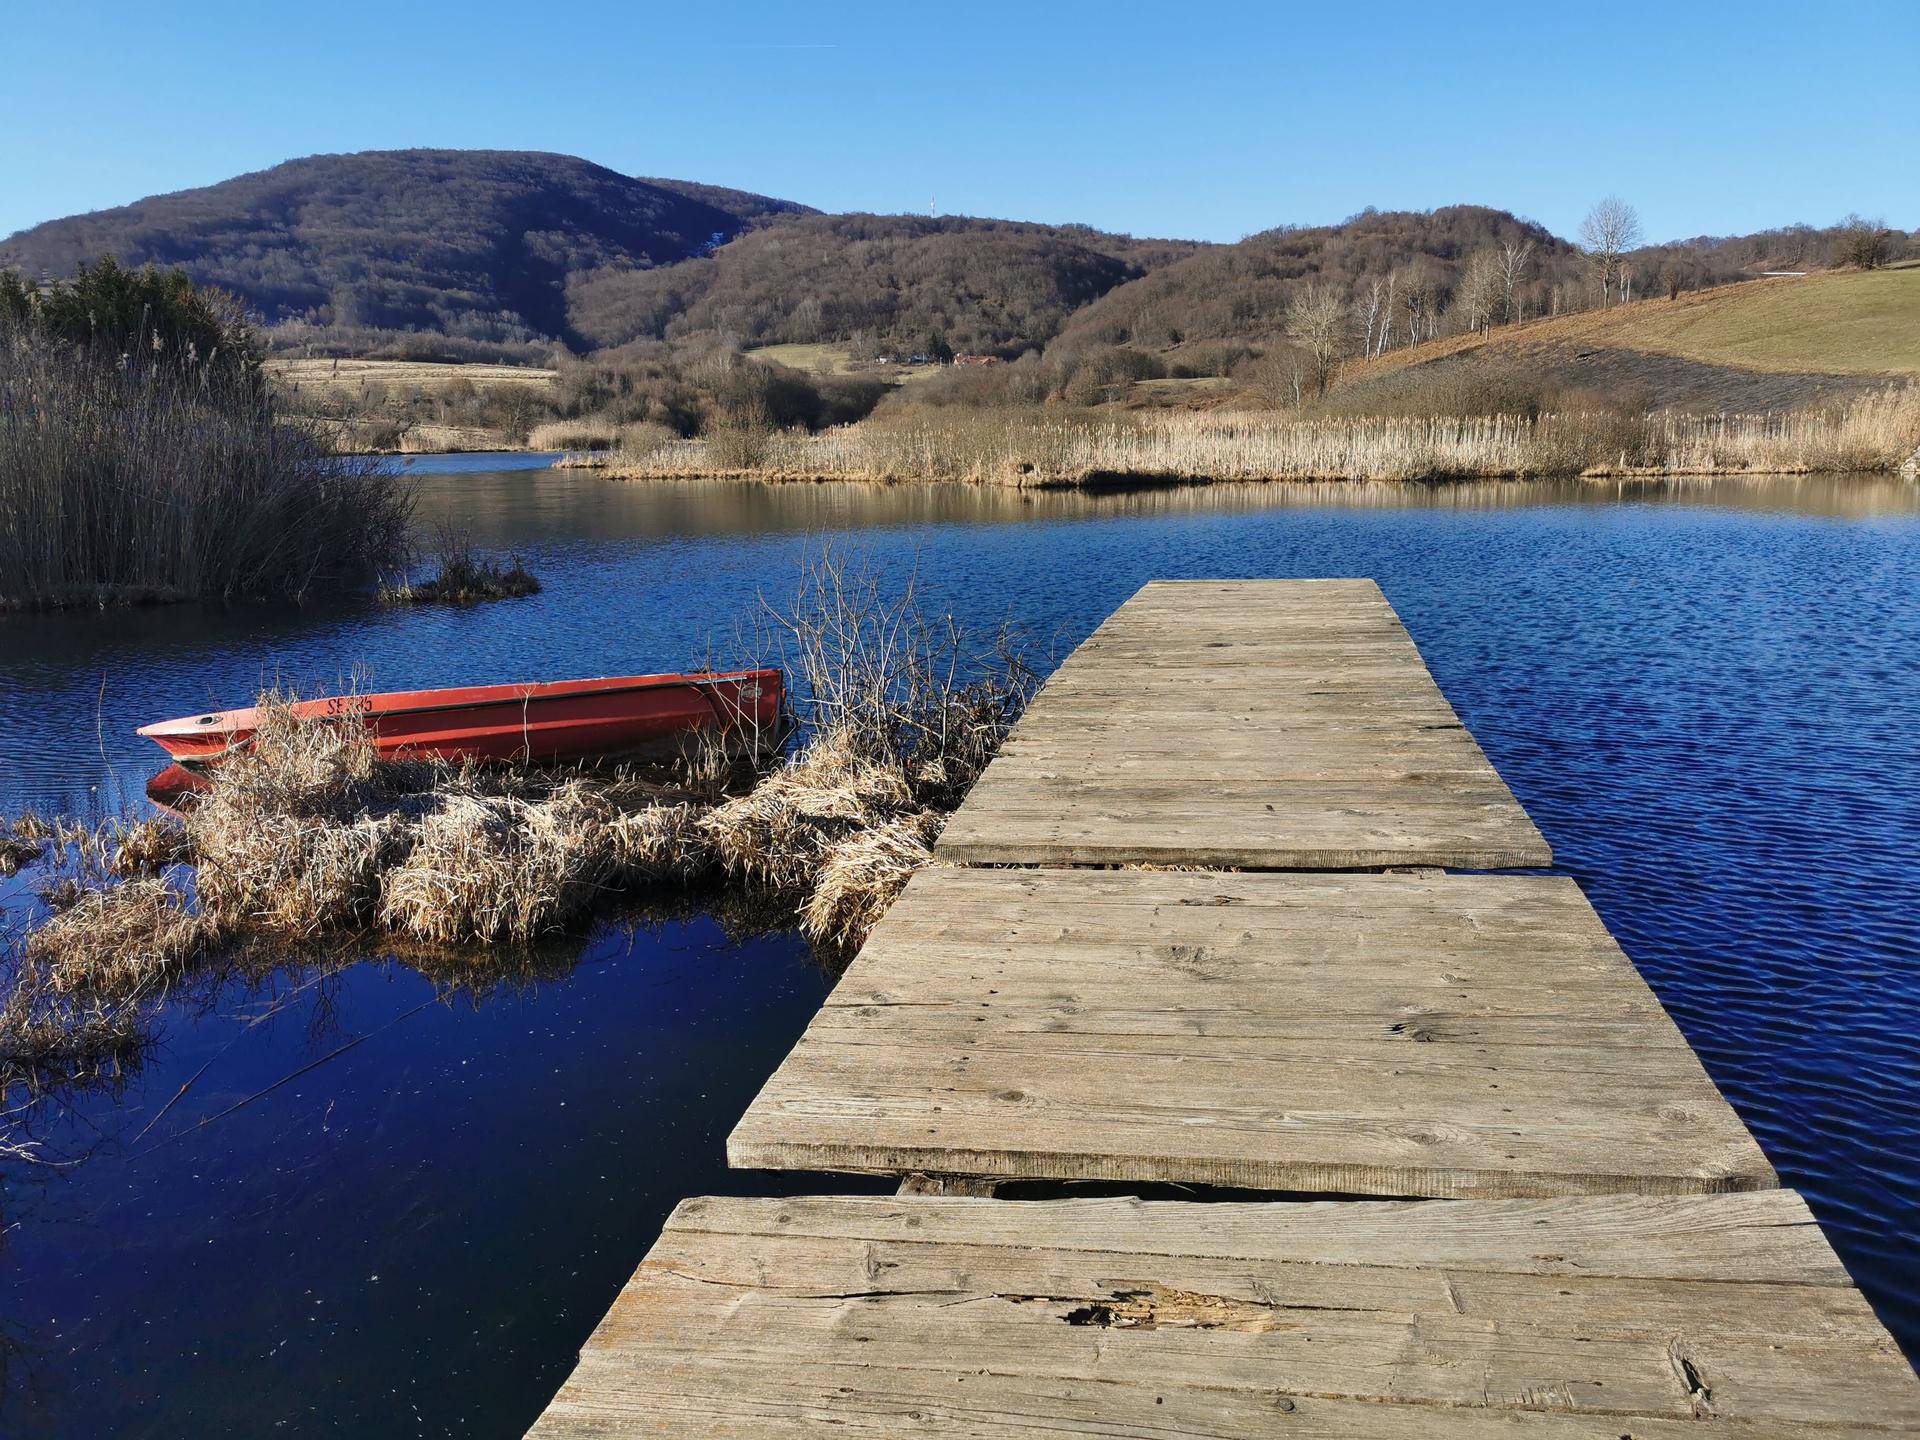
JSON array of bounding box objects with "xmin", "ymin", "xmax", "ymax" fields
[{"xmin": 935, "ymin": 580, "xmax": 1551, "ymax": 870}]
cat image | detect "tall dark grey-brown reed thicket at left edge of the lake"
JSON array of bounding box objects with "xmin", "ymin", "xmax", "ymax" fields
[{"xmin": 0, "ymin": 328, "xmax": 411, "ymax": 609}]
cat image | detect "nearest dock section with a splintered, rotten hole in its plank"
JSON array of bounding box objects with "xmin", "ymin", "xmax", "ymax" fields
[{"xmin": 532, "ymin": 1190, "xmax": 1920, "ymax": 1440}]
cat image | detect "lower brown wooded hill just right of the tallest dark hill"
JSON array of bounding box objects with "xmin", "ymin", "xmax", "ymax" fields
[{"xmin": 570, "ymin": 215, "xmax": 1202, "ymax": 353}]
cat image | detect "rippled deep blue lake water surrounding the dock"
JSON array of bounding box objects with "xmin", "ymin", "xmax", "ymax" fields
[{"xmin": 0, "ymin": 457, "xmax": 1920, "ymax": 1436}]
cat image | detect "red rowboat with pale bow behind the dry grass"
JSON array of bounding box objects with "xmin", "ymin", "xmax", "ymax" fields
[{"xmin": 140, "ymin": 670, "xmax": 781, "ymax": 764}]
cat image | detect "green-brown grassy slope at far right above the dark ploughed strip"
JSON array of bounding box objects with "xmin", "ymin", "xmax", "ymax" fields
[{"xmin": 1342, "ymin": 267, "xmax": 1920, "ymax": 378}]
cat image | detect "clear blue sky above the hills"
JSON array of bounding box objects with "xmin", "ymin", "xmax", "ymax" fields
[{"xmin": 0, "ymin": 0, "xmax": 1920, "ymax": 240}]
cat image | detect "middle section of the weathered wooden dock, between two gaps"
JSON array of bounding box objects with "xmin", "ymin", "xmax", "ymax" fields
[{"xmin": 728, "ymin": 868, "xmax": 1778, "ymax": 1198}]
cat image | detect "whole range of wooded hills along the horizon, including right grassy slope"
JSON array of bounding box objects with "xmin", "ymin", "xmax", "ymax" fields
[{"xmin": 0, "ymin": 150, "xmax": 1920, "ymax": 405}]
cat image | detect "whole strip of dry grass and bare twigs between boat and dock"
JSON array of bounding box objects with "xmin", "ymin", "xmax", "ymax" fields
[{"xmin": 0, "ymin": 559, "xmax": 1035, "ymax": 1089}]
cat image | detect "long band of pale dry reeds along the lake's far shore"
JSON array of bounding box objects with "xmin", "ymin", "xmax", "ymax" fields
[{"xmin": 609, "ymin": 386, "xmax": 1920, "ymax": 486}]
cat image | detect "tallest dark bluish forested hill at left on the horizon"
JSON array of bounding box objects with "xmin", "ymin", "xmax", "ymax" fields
[{"xmin": 0, "ymin": 150, "xmax": 806, "ymax": 355}]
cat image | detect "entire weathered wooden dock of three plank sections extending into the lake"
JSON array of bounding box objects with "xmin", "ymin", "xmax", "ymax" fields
[{"xmin": 534, "ymin": 580, "xmax": 1920, "ymax": 1440}]
